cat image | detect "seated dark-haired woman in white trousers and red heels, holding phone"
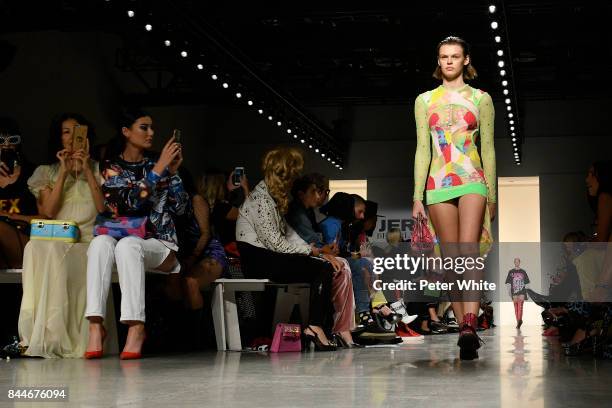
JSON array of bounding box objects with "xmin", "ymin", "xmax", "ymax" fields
[{"xmin": 85, "ymin": 110, "xmax": 189, "ymax": 360}]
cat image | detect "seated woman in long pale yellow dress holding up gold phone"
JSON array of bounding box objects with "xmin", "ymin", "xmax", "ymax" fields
[{"xmin": 19, "ymin": 113, "xmax": 104, "ymax": 358}]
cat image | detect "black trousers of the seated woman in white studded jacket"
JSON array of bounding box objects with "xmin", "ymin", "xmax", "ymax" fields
[{"xmin": 238, "ymin": 241, "xmax": 334, "ymax": 327}]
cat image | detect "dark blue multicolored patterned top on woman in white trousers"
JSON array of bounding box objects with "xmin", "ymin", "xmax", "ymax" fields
[{"xmin": 102, "ymin": 157, "xmax": 189, "ymax": 251}]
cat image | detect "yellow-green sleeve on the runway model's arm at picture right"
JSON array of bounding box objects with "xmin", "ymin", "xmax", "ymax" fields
[{"xmin": 479, "ymin": 92, "xmax": 497, "ymax": 203}]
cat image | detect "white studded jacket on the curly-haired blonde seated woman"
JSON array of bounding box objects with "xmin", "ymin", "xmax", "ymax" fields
[{"xmin": 236, "ymin": 180, "xmax": 310, "ymax": 255}]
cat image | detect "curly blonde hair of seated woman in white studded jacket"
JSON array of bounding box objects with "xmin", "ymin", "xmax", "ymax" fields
[{"xmin": 261, "ymin": 147, "xmax": 304, "ymax": 214}]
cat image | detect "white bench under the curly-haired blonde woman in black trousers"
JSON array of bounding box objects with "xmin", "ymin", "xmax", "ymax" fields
[{"xmin": 212, "ymin": 278, "xmax": 310, "ymax": 351}]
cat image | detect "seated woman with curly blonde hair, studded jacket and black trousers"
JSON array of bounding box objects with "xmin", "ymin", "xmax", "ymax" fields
[{"xmin": 236, "ymin": 147, "xmax": 342, "ymax": 351}]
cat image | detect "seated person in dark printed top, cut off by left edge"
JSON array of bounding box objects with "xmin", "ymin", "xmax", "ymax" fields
[{"xmin": 0, "ymin": 118, "xmax": 41, "ymax": 269}]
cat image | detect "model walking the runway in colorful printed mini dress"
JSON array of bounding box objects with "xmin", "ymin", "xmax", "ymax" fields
[{"xmin": 412, "ymin": 37, "xmax": 496, "ymax": 360}]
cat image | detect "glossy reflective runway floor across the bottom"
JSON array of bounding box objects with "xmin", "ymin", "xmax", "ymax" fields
[{"xmin": 0, "ymin": 326, "xmax": 612, "ymax": 408}]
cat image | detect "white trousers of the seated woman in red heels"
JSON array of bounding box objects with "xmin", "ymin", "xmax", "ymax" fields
[{"xmin": 85, "ymin": 235, "xmax": 180, "ymax": 322}]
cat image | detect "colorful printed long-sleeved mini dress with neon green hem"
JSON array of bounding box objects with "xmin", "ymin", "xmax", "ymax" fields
[{"xmin": 414, "ymin": 85, "xmax": 496, "ymax": 242}]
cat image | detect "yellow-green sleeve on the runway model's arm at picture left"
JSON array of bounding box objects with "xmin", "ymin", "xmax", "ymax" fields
[{"xmin": 413, "ymin": 95, "xmax": 431, "ymax": 201}]
